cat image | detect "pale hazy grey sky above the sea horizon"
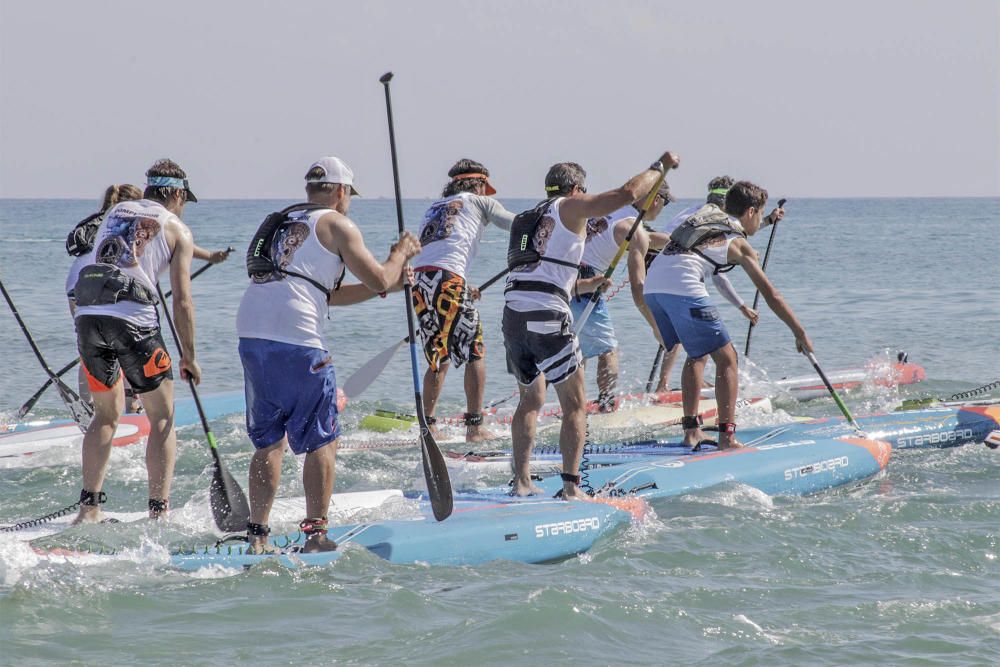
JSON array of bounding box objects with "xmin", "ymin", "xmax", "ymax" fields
[{"xmin": 0, "ymin": 0, "xmax": 1000, "ymax": 200}]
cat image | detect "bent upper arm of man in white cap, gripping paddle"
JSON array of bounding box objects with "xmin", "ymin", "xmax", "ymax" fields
[{"xmin": 316, "ymin": 212, "xmax": 420, "ymax": 292}]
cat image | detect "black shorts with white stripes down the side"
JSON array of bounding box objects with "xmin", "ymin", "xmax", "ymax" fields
[{"xmin": 502, "ymin": 306, "xmax": 582, "ymax": 385}]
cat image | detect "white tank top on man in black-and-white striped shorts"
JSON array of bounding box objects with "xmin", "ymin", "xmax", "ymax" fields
[{"xmin": 504, "ymin": 197, "xmax": 584, "ymax": 313}]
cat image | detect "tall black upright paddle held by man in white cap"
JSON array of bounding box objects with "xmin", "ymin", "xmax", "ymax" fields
[{"xmin": 379, "ymin": 72, "xmax": 454, "ymax": 521}]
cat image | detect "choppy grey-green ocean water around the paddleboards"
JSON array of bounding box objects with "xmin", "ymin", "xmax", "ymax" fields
[{"xmin": 0, "ymin": 199, "xmax": 1000, "ymax": 665}]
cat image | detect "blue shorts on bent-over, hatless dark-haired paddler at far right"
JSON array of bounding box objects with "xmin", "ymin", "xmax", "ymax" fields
[{"xmin": 645, "ymin": 293, "xmax": 732, "ymax": 359}]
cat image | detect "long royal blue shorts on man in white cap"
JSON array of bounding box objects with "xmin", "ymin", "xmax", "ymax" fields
[{"xmin": 239, "ymin": 338, "xmax": 340, "ymax": 454}]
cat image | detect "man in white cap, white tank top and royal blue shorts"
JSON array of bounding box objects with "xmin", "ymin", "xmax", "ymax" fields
[{"xmin": 236, "ymin": 157, "xmax": 420, "ymax": 552}]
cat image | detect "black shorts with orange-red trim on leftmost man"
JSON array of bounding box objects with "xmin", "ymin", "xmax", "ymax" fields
[{"xmin": 76, "ymin": 315, "xmax": 174, "ymax": 394}]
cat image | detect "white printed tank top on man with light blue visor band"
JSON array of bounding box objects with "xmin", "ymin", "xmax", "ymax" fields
[{"xmin": 74, "ymin": 199, "xmax": 179, "ymax": 327}]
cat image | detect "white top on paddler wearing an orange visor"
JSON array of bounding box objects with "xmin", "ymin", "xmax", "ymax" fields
[{"xmin": 413, "ymin": 192, "xmax": 486, "ymax": 278}]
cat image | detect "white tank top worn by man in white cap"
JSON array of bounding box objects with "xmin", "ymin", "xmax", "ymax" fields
[{"xmin": 236, "ymin": 209, "xmax": 344, "ymax": 350}]
